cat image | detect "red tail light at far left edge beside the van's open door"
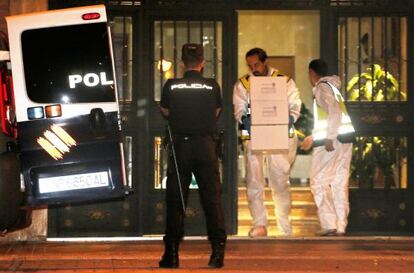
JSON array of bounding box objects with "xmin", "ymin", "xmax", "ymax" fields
[{"xmin": 0, "ymin": 63, "xmax": 17, "ymax": 138}]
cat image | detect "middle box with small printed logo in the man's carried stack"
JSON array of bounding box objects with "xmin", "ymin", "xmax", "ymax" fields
[{"xmin": 250, "ymin": 100, "xmax": 289, "ymax": 125}]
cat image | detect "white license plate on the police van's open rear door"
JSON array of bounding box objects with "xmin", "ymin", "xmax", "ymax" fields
[{"xmin": 39, "ymin": 172, "xmax": 109, "ymax": 193}]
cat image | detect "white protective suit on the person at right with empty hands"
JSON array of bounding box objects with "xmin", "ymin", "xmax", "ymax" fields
[{"xmin": 309, "ymin": 75, "xmax": 352, "ymax": 233}]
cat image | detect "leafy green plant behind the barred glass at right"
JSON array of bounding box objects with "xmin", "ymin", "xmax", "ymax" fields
[{"xmin": 346, "ymin": 64, "xmax": 407, "ymax": 189}]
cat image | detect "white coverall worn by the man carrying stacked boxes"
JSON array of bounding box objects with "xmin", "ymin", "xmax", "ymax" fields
[{"xmin": 233, "ymin": 67, "xmax": 302, "ymax": 235}]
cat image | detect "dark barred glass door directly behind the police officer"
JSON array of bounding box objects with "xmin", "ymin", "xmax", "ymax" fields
[{"xmin": 143, "ymin": 14, "xmax": 237, "ymax": 235}]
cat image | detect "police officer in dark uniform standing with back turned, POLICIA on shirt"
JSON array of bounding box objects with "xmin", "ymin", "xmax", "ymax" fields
[{"xmin": 159, "ymin": 44, "xmax": 226, "ymax": 268}]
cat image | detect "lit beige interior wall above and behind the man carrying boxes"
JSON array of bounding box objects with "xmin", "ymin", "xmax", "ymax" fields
[{"xmin": 238, "ymin": 10, "xmax": 320, "ymax": 110}]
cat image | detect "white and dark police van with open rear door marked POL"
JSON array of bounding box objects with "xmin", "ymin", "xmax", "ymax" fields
[{"xmin": 0, "ymin": 5, "xmax": 126, "ymax": 221}]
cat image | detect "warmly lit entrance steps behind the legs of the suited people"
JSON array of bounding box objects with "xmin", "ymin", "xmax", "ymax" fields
[{"xmin": 237, "ymin": 186, "xmax": 320, "ymax": 237}]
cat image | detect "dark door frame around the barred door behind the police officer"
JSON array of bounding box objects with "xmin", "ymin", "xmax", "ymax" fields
[{"xmin": 138, "ymin": 9, "xmax": 237, "ymax": 235}]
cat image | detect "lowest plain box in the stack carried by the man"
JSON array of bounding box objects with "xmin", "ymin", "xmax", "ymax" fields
[{"xmin": 250, "ymin": 124, "xmax": 289, "ymax": 154}]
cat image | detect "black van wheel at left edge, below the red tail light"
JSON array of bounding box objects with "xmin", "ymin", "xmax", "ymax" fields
[{"xmin": 0, "ymin": 152, "xmax": 28, "ymax": 234}]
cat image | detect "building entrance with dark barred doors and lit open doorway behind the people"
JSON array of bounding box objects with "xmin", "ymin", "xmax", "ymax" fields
[{"xmin": 43, "ymin": 0, "xmax": 414, "ymax": 237}]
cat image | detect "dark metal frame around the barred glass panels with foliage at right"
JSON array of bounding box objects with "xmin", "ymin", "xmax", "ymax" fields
[{"xmin": 321, "ymin": 6, "xmax": 414, "ymax": 235}]
